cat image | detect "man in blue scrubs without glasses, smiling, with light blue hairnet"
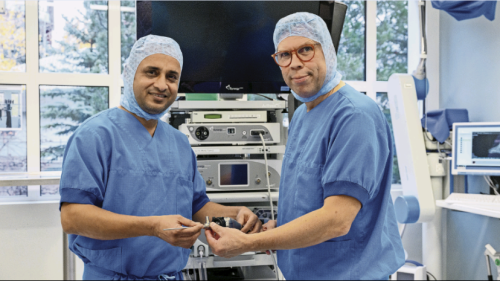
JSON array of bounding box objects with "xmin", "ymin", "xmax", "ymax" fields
[{"xmin": 60, "ymin": 35, "xmax": 261, "ymax": 280}]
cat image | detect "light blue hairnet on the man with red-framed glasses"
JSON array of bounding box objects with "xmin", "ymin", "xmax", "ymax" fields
[{"xmin": 273, "ymin": 12, "xmax": 342, "ymax": 102}]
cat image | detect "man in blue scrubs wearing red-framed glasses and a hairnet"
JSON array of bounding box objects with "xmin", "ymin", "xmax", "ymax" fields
[{"xmin": 206, "ymin": 13, "xmax": 404, "ymax": 280}]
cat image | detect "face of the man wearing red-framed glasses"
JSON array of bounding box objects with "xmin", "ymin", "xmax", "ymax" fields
[{"xmin": 278, "ymin": 36, "xmax": 326, "ymax": 98}]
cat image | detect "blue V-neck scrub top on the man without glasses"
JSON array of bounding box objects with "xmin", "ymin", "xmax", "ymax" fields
[{"xmin": 60, "ymin": 108, "xmax": 209, "ymax": 279}]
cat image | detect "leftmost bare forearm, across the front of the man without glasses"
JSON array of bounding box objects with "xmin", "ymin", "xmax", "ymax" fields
[{"xmin": 61, "ymin": 203, "xmax": 156, "ymax": 240}]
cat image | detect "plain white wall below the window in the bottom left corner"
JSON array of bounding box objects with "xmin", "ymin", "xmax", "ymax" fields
[{"xmin": 0, "ymin": 203, "xmax": 63, "ymax": 280}]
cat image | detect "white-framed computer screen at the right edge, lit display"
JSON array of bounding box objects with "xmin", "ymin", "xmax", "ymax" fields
[{"xmin": 452, "ymin": 123, "xmax": 500, "ymax": 175}]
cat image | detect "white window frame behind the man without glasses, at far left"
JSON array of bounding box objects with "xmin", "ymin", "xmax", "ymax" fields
[{"xmin": 0, "ymin": 1, "xmax": 123, "ymax": 202}]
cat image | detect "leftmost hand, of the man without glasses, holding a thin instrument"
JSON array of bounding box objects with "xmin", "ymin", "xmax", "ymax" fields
[{"xmin": 154, "ymin": 215, "xmax": 203, "ymax": 249}]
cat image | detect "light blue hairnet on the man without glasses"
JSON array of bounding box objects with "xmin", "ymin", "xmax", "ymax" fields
[{"xmin": 120, "ymin": 35, "xmax": 182, "ymax": 120}]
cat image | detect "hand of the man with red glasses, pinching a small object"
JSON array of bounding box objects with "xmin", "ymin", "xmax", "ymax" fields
[{"xmin": 205, "ymin": 223, "xmax": 251, "ymax": 258}]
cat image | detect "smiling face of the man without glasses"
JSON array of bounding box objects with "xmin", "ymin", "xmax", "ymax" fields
[{"xmin": 133, "ymin": 54, "xmax": 181, "ymax": 114}]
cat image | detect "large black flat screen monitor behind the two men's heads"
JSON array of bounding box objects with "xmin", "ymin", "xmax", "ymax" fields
[{"xmin": 137, "ymin": 1, "xmax": 347, "ymax": 93}]
